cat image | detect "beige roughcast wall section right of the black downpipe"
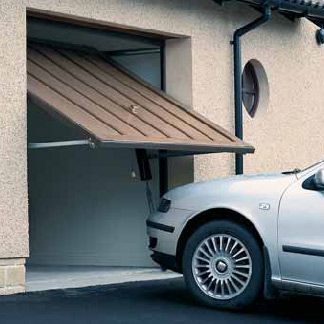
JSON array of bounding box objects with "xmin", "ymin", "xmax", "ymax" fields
[{"xmin": 243, "ymin": 17, "xmax": 324, "ymax": 173}]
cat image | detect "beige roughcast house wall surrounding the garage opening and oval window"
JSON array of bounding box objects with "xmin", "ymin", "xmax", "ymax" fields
[{"xmin": 0, "ymin": 0, "xmax": 324, "ymax": 257}]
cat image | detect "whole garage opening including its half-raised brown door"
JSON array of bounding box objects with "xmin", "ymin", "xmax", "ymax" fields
[{"xmin": 27, "ymin": 13, "xmax": 253, "ymax": 291}]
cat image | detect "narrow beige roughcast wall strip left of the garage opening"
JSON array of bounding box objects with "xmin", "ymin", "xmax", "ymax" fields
[{"xmin": 0, "ymin": 0, "xmax": 28, "ymax": 258}]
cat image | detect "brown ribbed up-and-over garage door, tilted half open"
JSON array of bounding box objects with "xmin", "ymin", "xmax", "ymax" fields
[{"xmin": 27, "ymin": 44, "xmax": 254, "ymax": 153}]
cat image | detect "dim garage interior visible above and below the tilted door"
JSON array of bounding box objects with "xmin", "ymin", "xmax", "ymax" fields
[{"xmin": 27, "ymin": 17, "xmax": 173, "ymax": 290}]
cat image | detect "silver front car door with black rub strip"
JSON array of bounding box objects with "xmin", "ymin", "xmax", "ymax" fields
[{"xmin": 278, "ymin": 170, "xmax": 324, "ymax": 285}]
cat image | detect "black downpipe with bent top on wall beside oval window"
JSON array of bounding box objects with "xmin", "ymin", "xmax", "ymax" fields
[{"xmin": 233, "ymin": 6, "xmax": 271, "ymax": 174}]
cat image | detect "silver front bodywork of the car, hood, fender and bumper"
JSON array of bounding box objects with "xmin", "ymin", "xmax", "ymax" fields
[{"xmin": 148, "ymin": 173, "xmax": 297, "ymax": 277}]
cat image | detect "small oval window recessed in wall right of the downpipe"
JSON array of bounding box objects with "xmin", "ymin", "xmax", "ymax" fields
[{"xmin": 242, "ymin": 60, "xmax": 269, "ymax": 117}]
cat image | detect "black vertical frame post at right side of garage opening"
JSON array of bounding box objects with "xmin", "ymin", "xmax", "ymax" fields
[{"xmin": 159, "ymin": 43, "xmax": 168, "ymax": 197}]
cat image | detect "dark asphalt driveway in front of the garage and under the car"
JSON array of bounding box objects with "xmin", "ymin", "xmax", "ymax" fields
[{"xmin": 0, "ymin": 278, "xmax": 324, "ymax": 324}]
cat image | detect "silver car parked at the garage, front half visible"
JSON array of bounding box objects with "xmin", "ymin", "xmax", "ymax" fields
[{"xmin": 147, "ymin": 161, "xmax": 324, "ymax": 309}]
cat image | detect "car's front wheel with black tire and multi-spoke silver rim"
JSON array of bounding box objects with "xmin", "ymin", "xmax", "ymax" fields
[{"xmin": 182, "ymin": 220, "xmax": 264, "ymax": 310}]
